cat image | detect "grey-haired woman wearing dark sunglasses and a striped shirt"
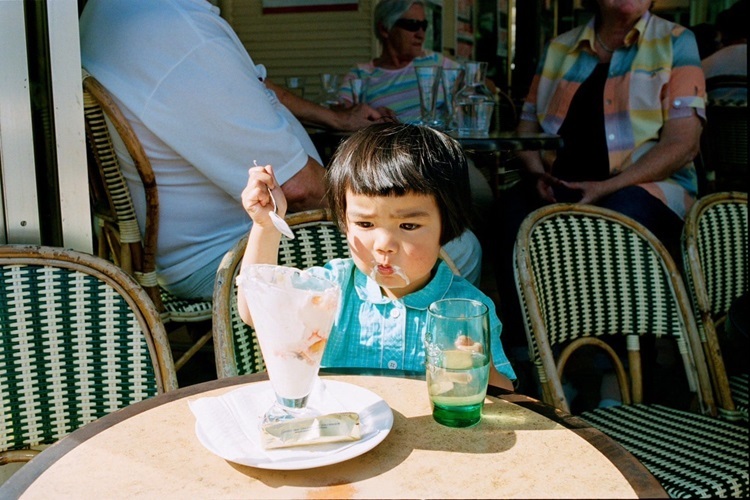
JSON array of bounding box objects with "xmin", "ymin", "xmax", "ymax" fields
[{"xmin": 339, "ymin": 0, "xmax": 459, "ymax": 123}]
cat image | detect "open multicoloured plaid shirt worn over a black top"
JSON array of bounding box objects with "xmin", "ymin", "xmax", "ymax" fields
[{"xmin": 521, "ymin": 12, "xmax": 706, "ymax": 218}]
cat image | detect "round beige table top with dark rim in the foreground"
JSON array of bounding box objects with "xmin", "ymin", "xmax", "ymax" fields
[{"xmin": 0, "ymin": 375, "xmax": 665, "ymax": 498}]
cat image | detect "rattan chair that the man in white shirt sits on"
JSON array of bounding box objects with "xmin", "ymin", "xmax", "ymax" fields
[{"xmin": 83, "ymin": 70, "xmax": 211, "ymax": 370}]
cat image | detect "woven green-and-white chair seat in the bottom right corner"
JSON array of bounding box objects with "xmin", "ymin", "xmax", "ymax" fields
[{"xmin": 581, "ymin": 405, "xmax": 750, "ymax": 498}]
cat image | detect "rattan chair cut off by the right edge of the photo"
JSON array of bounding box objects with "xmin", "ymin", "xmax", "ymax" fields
[{"xmin": 682, "ymin": 192, "xmax": 748, "ymax": 421}]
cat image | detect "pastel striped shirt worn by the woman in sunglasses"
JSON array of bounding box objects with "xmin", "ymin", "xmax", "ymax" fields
[{"xmin": 339, "ymin": 51, "xmax": 461, "ymax": 123}]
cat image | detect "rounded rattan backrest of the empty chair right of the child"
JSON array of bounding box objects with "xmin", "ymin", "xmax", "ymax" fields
[{"xmin": 515, "ymin": 204, "xmax": 715, "ymax": 412}]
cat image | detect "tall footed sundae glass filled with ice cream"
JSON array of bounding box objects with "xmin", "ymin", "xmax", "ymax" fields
[{"xmin": 237, "ymin": 264, "xmax": 340, "ymax": 425}]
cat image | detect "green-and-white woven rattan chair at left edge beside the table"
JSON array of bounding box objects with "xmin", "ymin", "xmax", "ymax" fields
[{"xmin": 0, "ymin": 245, "xmax": 177, "ymax": 465}]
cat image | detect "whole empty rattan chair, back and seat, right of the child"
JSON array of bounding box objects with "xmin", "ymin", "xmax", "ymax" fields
[{"xmin": 515, "ymin": 204, "xmax": 750, "ymax": 497}]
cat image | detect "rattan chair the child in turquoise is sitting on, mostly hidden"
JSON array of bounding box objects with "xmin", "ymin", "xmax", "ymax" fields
[{"xmin": 213, "ymin": 209, "xmax": 459, "ymax": 378}]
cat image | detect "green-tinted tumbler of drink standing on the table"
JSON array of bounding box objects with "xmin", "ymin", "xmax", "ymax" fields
[{"xmin": 425, "ymin": 299, "xmax": 490, "ymax": 427}]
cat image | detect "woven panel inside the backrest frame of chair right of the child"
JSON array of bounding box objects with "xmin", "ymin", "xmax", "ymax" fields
[{"xmin": 528, "ymin": 214, "xmax": 683, "ymax": 345}]
